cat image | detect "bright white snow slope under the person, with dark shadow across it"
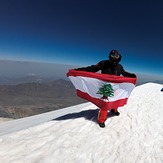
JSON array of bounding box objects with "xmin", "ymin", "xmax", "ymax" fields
[{"xmin": 0, "ymin": 83, "xmax": 163, "ymax": 163}]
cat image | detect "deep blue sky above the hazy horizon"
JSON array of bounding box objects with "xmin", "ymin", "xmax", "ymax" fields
[{"xmin": 0, "ymin": 0, "xmax": 163, "ymax": 75}]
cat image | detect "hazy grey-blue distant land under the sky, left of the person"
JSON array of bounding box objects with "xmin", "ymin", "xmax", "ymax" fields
[{"xmin": 0, "ymin": 60, "xmax": 76, "ymax": 85}]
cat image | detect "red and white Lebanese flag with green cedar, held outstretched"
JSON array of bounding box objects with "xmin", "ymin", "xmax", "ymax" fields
[{"xmin": 67, "ymin": 69, "xmax": 136, "ymax": 110}]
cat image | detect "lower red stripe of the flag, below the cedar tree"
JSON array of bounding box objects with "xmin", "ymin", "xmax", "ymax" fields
[{"xmin": 76, "ymin": 90, "xmax": 128, "ymax": 110}]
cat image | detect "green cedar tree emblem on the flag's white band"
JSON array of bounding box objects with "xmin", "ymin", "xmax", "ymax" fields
[{"xmin": 97, "ymin": 83, "xmax": 114, "ymax": 99}]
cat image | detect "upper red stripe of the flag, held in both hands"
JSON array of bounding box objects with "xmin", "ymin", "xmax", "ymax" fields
[{"xmin": 67, "ymin": 69, "xmax": 136, "ymax": 85}]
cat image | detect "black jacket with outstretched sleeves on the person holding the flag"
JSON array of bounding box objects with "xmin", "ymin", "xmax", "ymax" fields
[{"xmin": 75, "ymin": 60, "xmax": 136, "ymax": 78}]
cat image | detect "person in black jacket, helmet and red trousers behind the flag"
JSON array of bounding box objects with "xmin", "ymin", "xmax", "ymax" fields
[{"xmin": 75, "ymin": 50, "xmax": 136, "ymax": 127}]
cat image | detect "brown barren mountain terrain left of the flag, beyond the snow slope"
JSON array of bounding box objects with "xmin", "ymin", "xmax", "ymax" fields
[{"xmin": 0, "ymin": 79, "xmax": 86, "ymax": 118}]
